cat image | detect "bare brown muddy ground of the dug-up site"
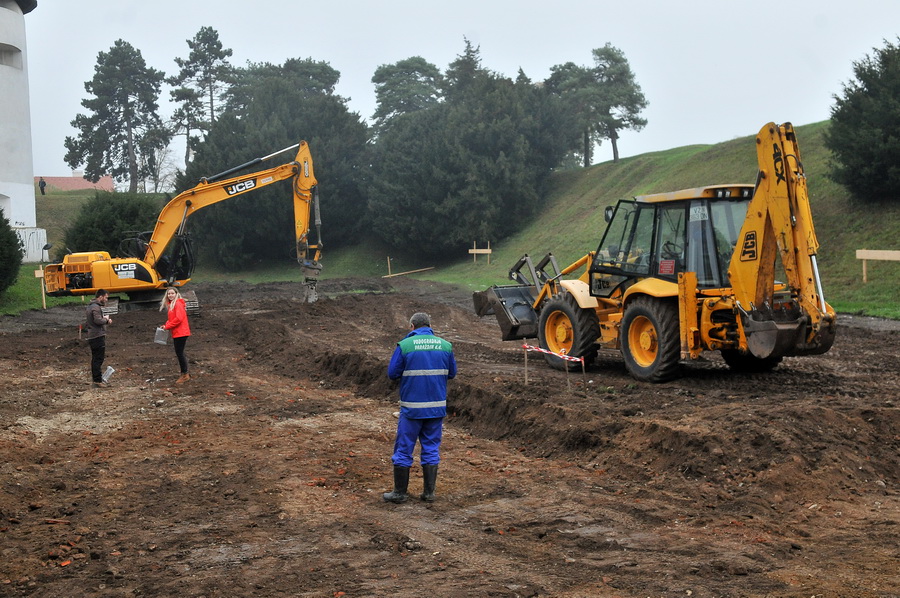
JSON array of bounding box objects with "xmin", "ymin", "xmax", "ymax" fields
[{"xmin": 0, "ymin": 278, "xmax": 900, "ymax": 598}]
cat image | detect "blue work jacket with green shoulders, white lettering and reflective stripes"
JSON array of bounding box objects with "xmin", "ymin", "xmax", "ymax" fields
[{"xmin": 388, "ymin": 326, "xmax": 456, "ymax": 419}]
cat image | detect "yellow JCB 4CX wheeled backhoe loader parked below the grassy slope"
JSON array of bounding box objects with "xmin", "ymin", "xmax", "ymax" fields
[{"xmin": 473, "ymin": 123, "xmax": 835, "ymax": 382}]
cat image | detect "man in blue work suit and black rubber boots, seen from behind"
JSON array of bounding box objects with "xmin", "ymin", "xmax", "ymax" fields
[{"xmin": 383, "ymin": 312, "xmax": 456, "ymax": 503}]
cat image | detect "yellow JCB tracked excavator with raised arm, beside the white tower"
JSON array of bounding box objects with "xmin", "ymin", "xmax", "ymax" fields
[{"xmin": 44, "ymin": 141, "xmax": 322, "ymax": 313}]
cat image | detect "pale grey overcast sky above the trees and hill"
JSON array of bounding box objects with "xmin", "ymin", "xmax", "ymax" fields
[{"xmin": 19, "ymin": 0, "xmax": 900, "ymax": 176}]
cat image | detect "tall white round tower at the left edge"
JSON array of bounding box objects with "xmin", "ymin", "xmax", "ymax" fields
[{"xmin": 0, "ymin": 0, "xmax": 47, "ymax": 262}]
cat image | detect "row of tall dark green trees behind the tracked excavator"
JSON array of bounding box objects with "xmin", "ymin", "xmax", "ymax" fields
[{"xmin": 65, "ymin": 27, "xmax": 647, "ymax": 268}]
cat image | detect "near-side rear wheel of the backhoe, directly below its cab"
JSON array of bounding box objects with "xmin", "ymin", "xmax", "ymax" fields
[{"xmin": 619, "ymin": 297, "xmax": 681, "ymax": 382}]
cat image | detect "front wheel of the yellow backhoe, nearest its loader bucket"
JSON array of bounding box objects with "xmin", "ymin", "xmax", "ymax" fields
[{"xmin": 538, "ymin": 291, "xmax": 600, "ymax": 371}]
